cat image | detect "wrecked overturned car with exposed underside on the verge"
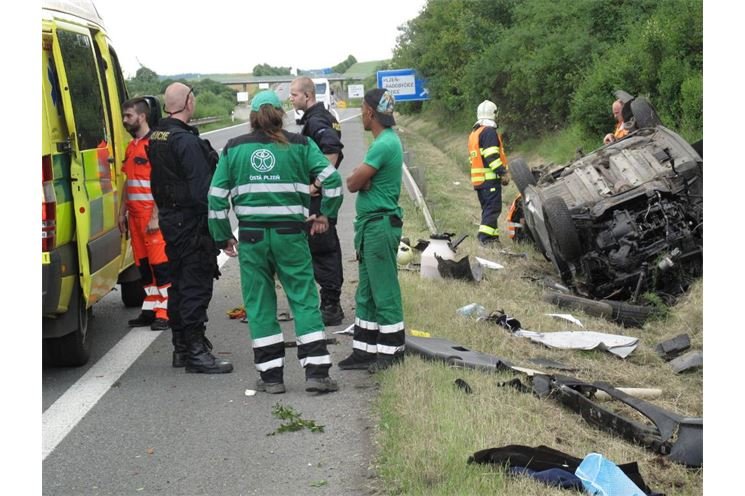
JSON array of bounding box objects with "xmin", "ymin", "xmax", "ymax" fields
[{"xmin": 510, "ymin": 97, "xmax": 704, "ymax": 302}]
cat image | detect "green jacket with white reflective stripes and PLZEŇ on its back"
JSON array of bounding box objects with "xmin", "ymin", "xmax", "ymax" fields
[{"xmin": 208, "ymin": 131, "xmax": 342, "ymax": 245}]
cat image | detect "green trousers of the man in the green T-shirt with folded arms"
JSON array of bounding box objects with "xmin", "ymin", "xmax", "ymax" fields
[{"xmin": 352, "ymin": 215, "xmax": 405, "ymax": 360}]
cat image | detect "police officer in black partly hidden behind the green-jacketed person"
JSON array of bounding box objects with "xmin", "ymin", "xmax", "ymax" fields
[{"xmin": 290, "ymin": 77, "xmax": 344, "ymax": 326}]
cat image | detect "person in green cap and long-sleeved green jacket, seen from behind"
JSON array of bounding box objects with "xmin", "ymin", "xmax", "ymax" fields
[{"xmin": 209, "ymin": 90, "xmax": 342, "ymax": 394}]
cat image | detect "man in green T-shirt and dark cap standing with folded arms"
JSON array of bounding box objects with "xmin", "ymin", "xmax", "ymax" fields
[{"xmin": 339, "ymin": 88, "xmax": 405, "ymax": 373}]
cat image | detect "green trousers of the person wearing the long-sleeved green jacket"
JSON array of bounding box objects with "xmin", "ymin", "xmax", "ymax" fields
[{"xmin": 238, "ymin": 227, "xmax": 331, "ymax": 382}]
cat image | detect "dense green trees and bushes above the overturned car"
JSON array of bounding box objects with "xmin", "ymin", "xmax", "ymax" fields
[{"xmin": 391, "ymin": 0, "xmax": 703, "ymax": 141}]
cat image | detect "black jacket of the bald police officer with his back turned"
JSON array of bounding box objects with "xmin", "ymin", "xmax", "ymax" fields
[{"xmin": 148, "ymin": 117, "xmax": 218, "ymax": 248}]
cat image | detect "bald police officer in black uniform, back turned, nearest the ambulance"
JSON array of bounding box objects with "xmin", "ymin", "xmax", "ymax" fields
[{"xmin": 148, "ymin": 83, "xmax": 233, "ymax": 374}]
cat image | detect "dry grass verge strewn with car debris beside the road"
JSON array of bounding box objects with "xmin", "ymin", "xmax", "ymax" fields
[{"xmin": 376, "ymin": 116, "xmax": 703, "ymax": 496}]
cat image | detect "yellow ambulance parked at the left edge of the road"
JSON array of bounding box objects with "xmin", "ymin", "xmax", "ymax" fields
[{"xmin": 41, "ymin": 0, "xmax": 144, "ymax": 366}]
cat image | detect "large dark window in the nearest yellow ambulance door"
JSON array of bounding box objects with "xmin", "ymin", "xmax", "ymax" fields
[{"xmin": 57, "ymin": 30, "xmax": 106, "ymax": 150}]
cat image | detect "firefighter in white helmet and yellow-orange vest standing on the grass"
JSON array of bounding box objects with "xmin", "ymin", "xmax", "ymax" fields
[{"xmin": 468, "ymin": 100, "xmax": 510, "ymax": 246}]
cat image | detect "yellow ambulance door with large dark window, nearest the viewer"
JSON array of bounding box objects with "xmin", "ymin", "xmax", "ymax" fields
[{"xmin": 53, "ymin": 22, "xmax": 121, "ymax": 305}]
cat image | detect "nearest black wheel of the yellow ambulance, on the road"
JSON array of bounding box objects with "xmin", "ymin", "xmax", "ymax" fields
[{"xmin": 42, "ymin": 285, "xmax": 90, "ymax": 367}]
